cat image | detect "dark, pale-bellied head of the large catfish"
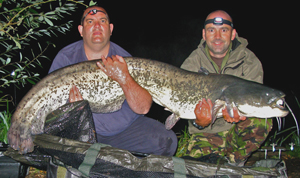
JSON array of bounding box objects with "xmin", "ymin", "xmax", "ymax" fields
[{"xmin": 222, "ymin": 82, "xmax": 289, "ymax": 118}]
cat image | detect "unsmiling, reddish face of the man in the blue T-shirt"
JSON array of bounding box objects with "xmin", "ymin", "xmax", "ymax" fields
[{"xmin": 78, "ymin": 8, "xmax": 113, "ymax": 44}]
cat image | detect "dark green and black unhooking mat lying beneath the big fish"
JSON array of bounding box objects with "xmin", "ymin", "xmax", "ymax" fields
[{"xmin": 5, "ymin": 101, "xmax": 287, "ymax": 178}]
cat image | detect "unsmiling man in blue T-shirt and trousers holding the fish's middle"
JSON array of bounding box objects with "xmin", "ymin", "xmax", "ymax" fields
[{"xmin": 49, "ymin": 6, "xmax": 177, "ymax": 156}]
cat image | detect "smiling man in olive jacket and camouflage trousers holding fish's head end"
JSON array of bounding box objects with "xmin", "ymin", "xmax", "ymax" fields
[{"xmin": 177, "ymin": 10, "xmax": 272, "ymax": 166}]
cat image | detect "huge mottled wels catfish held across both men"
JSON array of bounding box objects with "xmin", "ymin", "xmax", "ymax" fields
[{"xmin": 8, "ymin": 57, "xmax": 288, "ymax": 153}]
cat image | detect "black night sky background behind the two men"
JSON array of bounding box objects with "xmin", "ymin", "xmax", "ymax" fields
[{"xmin": 7, "ymin": 1, "xmax": 300, "ymax": 134}]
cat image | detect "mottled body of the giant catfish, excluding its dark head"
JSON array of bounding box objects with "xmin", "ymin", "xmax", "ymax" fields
[{"xmin": 8, "ymin": 57, "xmax": 288, "ymax": 153}]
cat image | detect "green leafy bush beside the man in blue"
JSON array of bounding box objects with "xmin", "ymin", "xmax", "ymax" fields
[{"xmin": 0, "ymin": 0, "xmax": 95, "ymax": 143}]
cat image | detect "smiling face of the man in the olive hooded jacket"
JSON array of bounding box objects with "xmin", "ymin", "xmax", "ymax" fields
[{"xmin": 202, "ymin": 23, "xmax": 236, "ymax": 57}]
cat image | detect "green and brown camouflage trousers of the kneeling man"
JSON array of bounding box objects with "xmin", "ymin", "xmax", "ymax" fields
[{"xmin": 176, "ymin": 118, "xmax": 273, "ymax": 163}]
